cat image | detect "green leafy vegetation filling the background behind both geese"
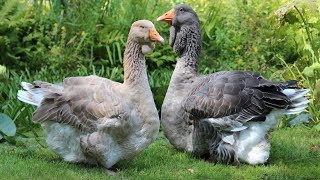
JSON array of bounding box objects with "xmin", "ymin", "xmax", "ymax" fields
[{"xmin": 0, "ymin": 0, "xmax": 320, "ymax": 177}]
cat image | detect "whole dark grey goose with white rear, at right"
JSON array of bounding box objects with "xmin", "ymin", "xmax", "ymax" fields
[{"xmin": 157, "ymin": 4, "xmax": 309, "ymax": 165}]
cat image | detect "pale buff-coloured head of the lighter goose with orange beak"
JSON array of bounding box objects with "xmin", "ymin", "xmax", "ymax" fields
[{"xmin": 128, "ymin": 20, "xmax": 164, "ymax": 54}]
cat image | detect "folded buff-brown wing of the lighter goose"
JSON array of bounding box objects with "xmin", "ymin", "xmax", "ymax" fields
[{"xmin": 33, "ymin": 76, "xmax": 126, "ymax": 131}]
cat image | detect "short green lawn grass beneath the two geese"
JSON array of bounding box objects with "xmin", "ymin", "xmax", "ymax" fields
[{"xmin": 0, "ymin": 127, "xmax": 320, "ymax": 179}]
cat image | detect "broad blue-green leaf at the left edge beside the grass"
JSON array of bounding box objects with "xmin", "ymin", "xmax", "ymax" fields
[{"xmin": 0, "ymin": 113, "xmax": 16, "ymax": 139}]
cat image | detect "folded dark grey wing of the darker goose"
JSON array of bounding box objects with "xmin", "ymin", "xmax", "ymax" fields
[{"xmin": 183, "ymin": 71, "xmax": 295, "ymax": 123}]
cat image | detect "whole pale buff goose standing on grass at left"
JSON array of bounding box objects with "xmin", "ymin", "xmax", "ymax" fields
[{"xmin": 17, "ymin": 20, "xmax": 164, "ymax": 174}]
